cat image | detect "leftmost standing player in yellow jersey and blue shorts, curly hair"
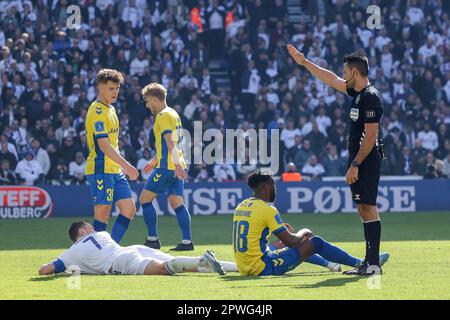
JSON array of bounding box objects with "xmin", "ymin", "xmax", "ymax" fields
[{"xmin": 86, "ymin": 69, "xmax": 139, "ymax": 243}]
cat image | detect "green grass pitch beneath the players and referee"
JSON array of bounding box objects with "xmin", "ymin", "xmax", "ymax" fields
[{"xmin": 0, "ymin": 212, "xmax": 450, "ymax": 300}]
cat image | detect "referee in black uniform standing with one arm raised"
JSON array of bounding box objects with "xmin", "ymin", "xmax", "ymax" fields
[{"xmin": 288, "ymin": 45, "xmax": 384, "ymax": 275}]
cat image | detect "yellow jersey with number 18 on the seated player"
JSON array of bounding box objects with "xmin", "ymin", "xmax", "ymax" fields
[{"xmin": 233, "ymin": 198, "xmax": 286, "ymax": 275}]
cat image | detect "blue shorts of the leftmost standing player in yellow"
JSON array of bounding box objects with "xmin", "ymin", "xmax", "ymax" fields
[{"xmin": 86, "ymin": 173, "xmax": 132, "ymax": 206}]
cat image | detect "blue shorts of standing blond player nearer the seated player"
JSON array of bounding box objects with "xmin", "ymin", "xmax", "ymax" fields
[{"xmin": 144, "ymin": 168, "xmax": 184, "ymax": 197}]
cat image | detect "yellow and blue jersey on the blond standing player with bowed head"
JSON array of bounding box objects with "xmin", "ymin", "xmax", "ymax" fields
[{"xmin": 153, "ymin": 107, "xmax": 186, "ymax": 170}]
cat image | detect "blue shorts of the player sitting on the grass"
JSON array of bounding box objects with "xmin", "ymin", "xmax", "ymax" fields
[{"xmin": 259, "ymin": 246, "xmax": 302, "ymax": 276}]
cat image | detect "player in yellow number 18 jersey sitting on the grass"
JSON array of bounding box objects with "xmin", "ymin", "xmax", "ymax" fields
[{"xmin": 233, "ymin": 170, "xmax": 389, "ymax": 276}]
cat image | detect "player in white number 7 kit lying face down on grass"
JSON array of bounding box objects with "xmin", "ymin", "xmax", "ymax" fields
[{"xmin": 39, "ymin": 221, "xmax": 237, "ymax": 275}]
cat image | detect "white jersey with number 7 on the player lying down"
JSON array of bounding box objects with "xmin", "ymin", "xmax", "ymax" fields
[{"xmin": 58, "ymin": 231, "xmax": 123, "ymax": 274}]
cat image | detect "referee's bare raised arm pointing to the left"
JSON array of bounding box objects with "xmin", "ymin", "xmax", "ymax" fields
[{"xmin": 287, "ymin": 44, "xmax": 347, "ymax": 93}]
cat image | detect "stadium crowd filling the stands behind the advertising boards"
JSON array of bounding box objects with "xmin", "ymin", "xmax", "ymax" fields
[{"xmin": 0, "ymin": 0, "xmax": 450, "ymax": 185}]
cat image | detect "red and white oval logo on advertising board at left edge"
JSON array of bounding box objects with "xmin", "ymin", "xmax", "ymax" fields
[{"xmin": 0, "ymin": 186, "xmax": 53, "ymax": 219}]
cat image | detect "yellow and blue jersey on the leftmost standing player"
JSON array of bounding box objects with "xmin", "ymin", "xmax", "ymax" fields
[{"xmin": 85, "ymin": 101, "xmax": 121, "ymax": 174}]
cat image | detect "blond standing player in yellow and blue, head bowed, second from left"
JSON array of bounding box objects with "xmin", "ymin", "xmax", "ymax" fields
[{"xmin": 139, "ymin": 83, "xmax": 194, "ymax": 251}]
